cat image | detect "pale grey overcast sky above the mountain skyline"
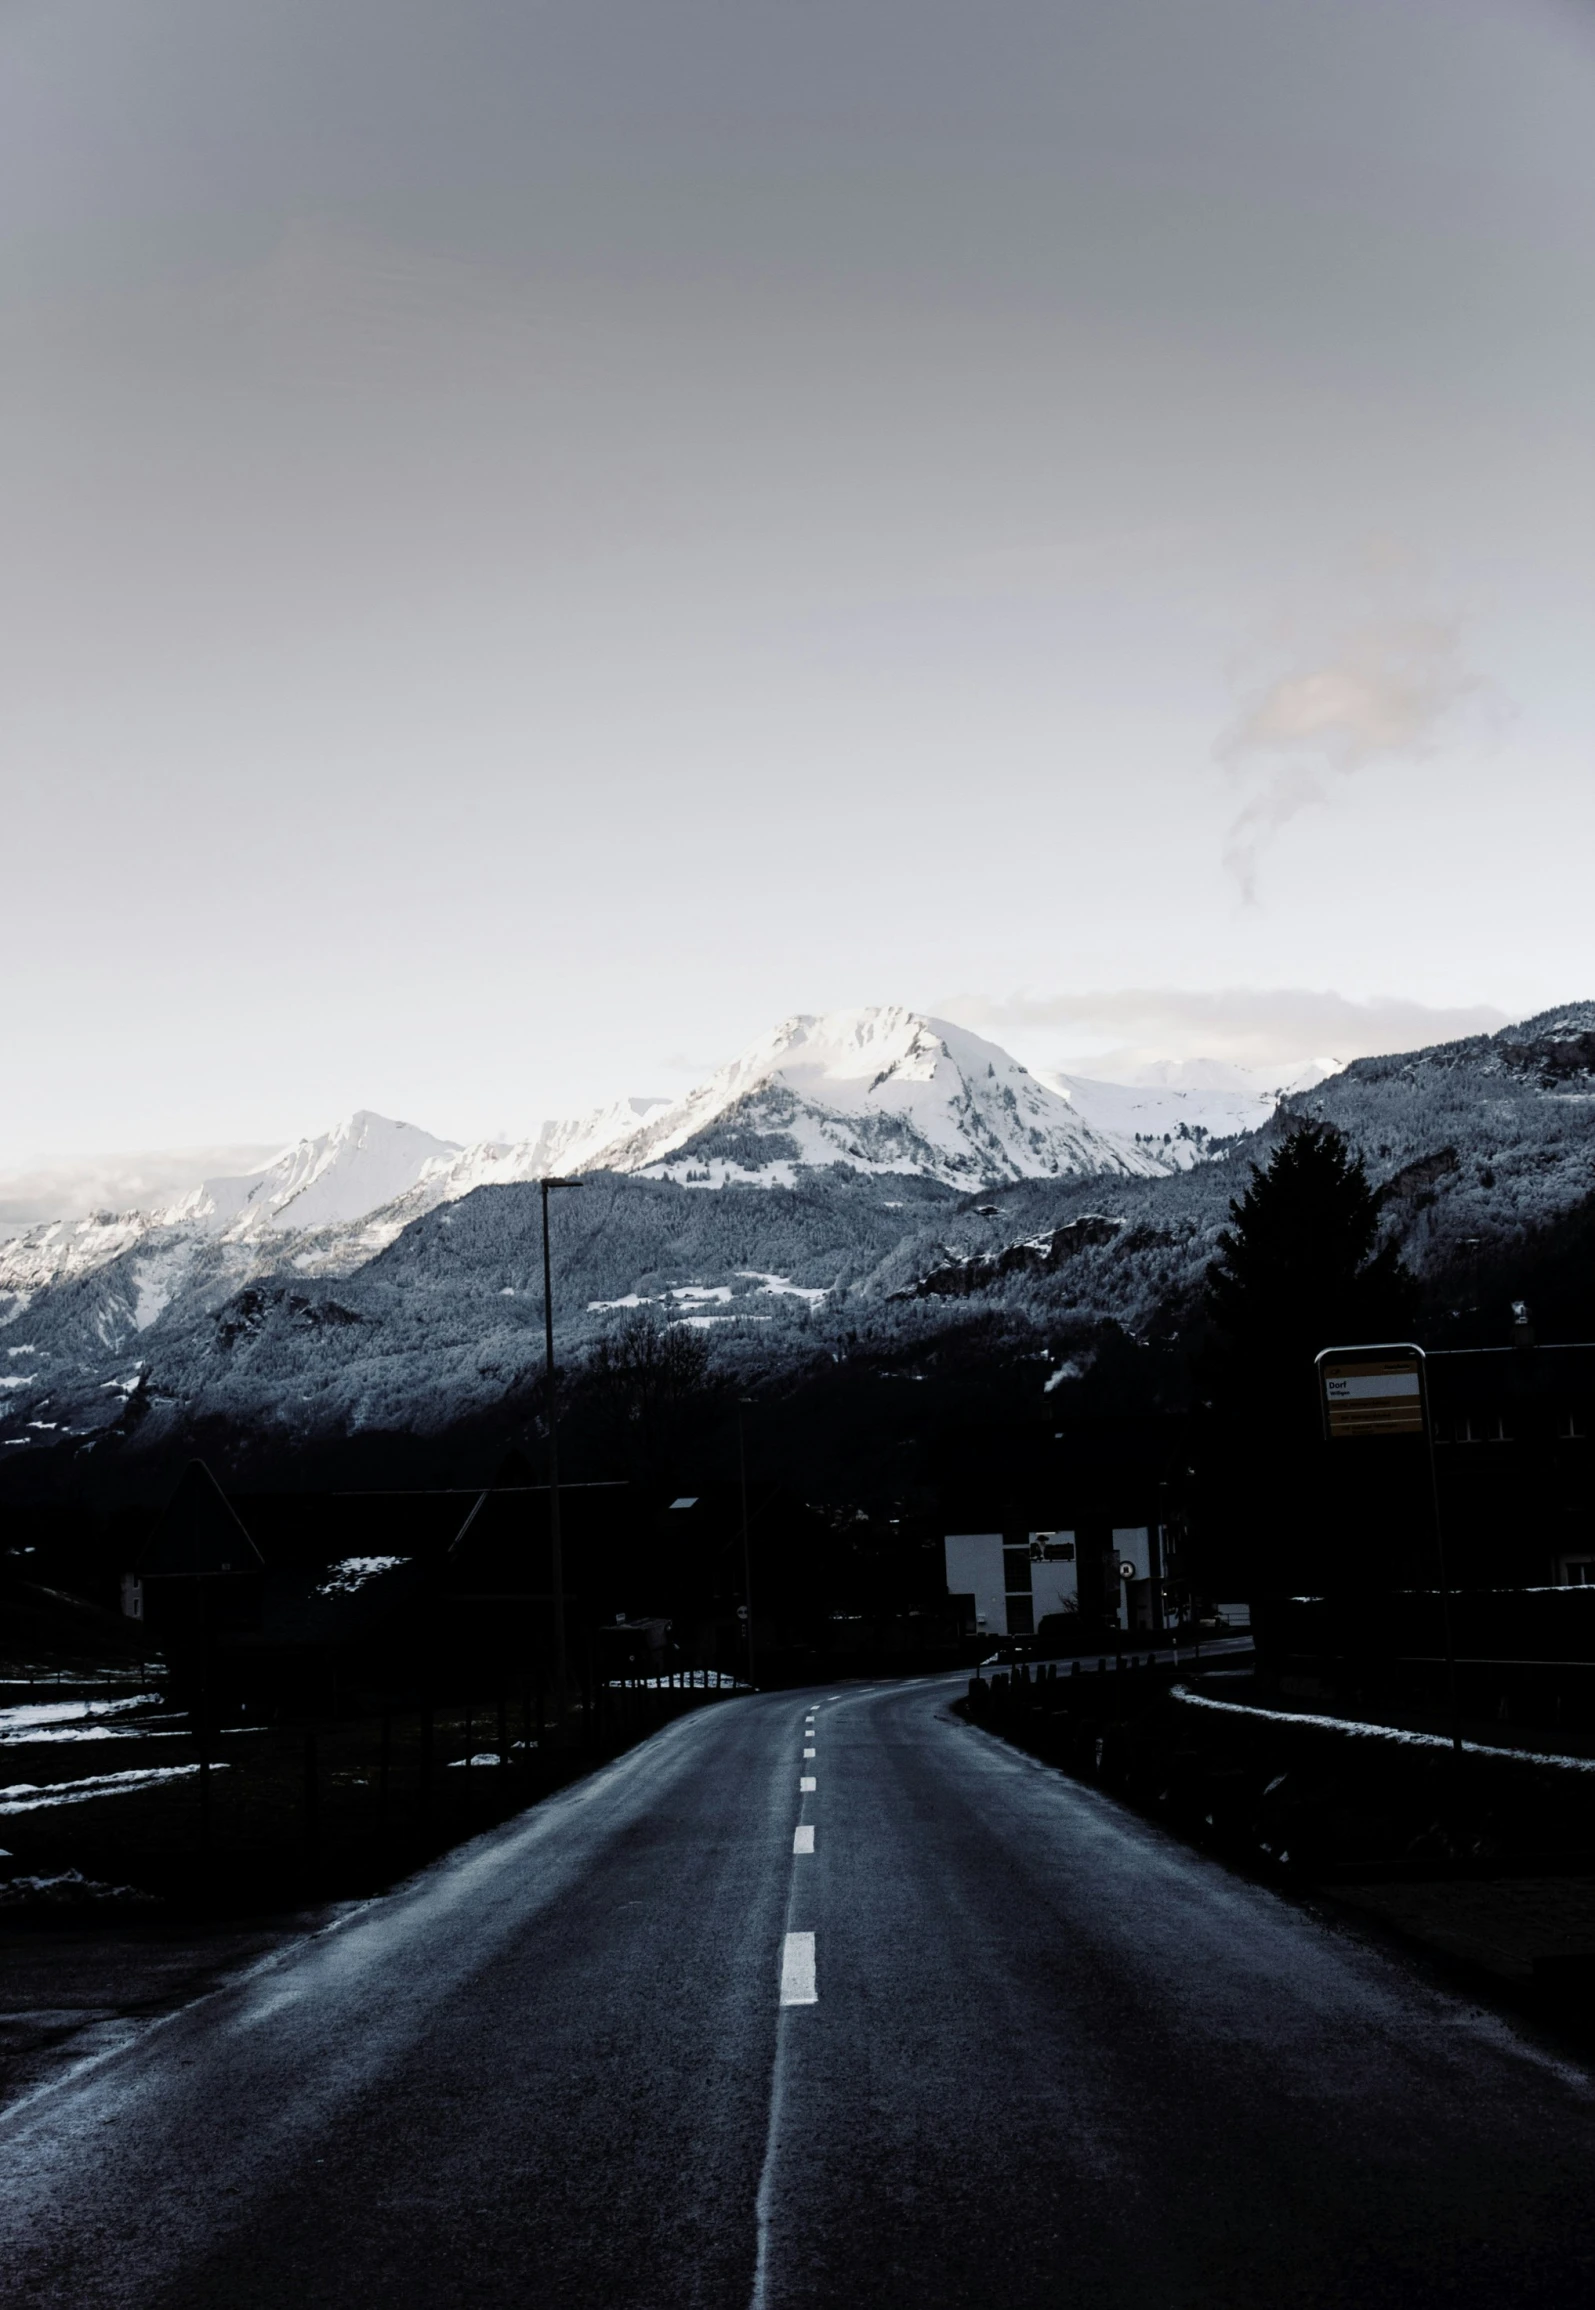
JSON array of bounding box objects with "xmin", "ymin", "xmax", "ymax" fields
[{"xmin": 0, "ymin": 0, "xmax": 1595, "ymax": 1164}]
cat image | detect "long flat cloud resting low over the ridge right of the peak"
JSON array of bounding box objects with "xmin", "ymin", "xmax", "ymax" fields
[{"xmin": 941, "ymin": 986, "xmax": 1507, "ymax": 1067}]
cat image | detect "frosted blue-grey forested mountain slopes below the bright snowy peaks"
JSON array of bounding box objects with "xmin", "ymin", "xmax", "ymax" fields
[{"xmin": 0, "ymin": 1003, "xmax": 1595, "ymax": 1467}]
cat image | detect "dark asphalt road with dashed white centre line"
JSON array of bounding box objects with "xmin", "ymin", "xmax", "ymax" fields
[{"xmin": 0, "ymin": 1682, "xmax": 1595, "ymax": 2310}]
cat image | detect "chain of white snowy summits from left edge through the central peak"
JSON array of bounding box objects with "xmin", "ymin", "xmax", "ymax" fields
[{"xmin": 0, "ymin": 1007, "xmax": 1184, "ymax": 1321}]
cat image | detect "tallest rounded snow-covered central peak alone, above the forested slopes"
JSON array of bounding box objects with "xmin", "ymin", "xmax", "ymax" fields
[{"xmin": 580, "ymin": 1005, "xmax": 1167, "ymax": 1187}]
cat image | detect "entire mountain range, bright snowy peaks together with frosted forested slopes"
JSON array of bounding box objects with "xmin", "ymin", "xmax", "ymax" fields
[{"xmin": 0, "ymin": 1005, "xmax": 1595, "ymax": 1481}]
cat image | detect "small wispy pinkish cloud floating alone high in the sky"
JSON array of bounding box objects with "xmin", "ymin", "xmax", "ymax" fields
[{"xmin": 1214, "ymin": 617, "xmax": 1479, "ymax": 903}]
